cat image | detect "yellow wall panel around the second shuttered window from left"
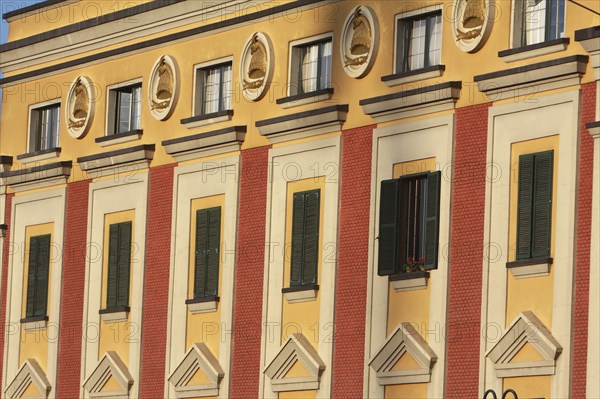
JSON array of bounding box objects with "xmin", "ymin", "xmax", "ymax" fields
[{"xmin": 98, "ymin": 210, "xmax": 135, "ymax": 365}]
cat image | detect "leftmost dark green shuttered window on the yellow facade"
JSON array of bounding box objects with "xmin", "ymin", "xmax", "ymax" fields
[{"xmin": 25, "ymin": 234, "xmax": 50, "ymax": 318}]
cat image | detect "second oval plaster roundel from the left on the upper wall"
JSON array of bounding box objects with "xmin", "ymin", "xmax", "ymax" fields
[{"xmin": 148, "ymin": 55, "xmax": 179, "ymax": 121}]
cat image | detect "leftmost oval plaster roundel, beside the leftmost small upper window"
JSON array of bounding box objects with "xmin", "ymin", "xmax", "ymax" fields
[{"xmin": 65, "ymin": 76, "xmax": 96, "ymax": 139}]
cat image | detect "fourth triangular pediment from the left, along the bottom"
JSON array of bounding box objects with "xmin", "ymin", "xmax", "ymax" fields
[{"xmin": 264, "ymin": 334, "xmax": 325, "ymax": 392}]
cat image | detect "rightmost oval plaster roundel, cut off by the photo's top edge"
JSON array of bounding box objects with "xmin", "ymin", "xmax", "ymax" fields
[{"xmin": 452, "ymin": 0, "xmax": 495, "ymax": 53}]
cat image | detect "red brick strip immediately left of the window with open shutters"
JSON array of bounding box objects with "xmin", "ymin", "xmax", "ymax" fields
[{"xmin": 333, "ymin": 126, "xmax": 375, "ymax": 399}]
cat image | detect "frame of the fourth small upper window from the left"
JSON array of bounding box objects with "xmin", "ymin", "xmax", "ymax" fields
[{"xmin": 287, "ymin": 32, "xmax": 335, "ymax": 97}]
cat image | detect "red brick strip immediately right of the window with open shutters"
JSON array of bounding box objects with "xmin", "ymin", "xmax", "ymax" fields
[{"xmin": 444, "ymin": 104, "xmax": 490, "ymax": 399}]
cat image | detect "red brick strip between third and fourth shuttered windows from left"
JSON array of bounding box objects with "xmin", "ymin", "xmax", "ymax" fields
[{"xmin": 229, "ymin": 146, "xmax": 270, "ymax": 399}]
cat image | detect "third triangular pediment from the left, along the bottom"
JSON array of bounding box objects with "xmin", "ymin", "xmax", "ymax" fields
[{"xmin": 169, "ymin": 343, "xmax": 225, "ymax": 398}]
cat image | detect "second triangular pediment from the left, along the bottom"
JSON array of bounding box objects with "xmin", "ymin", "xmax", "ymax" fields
[{"xmin": 83, "ymin": 351, "xmax": 133, "ymax": 398}]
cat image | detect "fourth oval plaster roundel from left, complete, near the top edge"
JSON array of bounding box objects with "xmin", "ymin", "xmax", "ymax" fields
[{"xmin": 340, "ymin": 6, "xmax": 379, "ymax": 78}]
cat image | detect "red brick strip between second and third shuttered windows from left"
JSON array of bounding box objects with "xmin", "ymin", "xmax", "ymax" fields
[{"xmin": 140, "ymin": 164, "xmax": 175, "ymax": 399}]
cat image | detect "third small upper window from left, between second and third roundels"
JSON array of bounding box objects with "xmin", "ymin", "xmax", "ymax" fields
[{"xmin": 194, "ymin": 62, "xmax": 233, "ymax": 115}]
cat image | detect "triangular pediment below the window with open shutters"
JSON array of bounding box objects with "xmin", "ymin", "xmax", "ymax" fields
[{"xmin": 369, "ymin": 323, "xmax": 437, "ymax": 385}]
